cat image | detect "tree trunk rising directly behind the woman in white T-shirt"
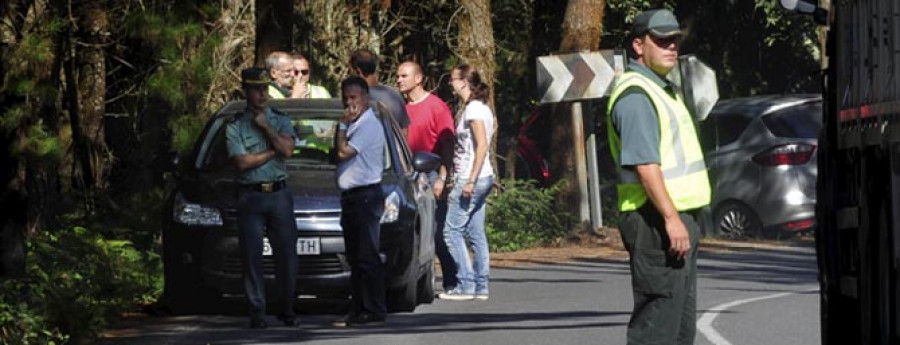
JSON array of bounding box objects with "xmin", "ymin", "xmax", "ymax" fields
[{"xmin": 459, "ymin": 0, "xmax": 498, "ymax": 176}]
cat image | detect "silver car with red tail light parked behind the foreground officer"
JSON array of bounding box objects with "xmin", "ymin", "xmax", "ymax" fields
[{"xmin": 698, "ymin": 95, "xmax": 822, "ymax": 237}]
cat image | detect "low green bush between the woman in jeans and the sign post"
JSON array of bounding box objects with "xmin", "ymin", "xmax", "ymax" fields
[{"xmin": 486, "ymin": 179, "xmax": 574, "ymax": 252}]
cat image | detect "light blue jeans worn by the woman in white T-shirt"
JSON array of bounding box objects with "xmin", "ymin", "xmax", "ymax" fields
[{"xmin": 444, "ymin": 176, "xmax": 494, "ymax": 294}]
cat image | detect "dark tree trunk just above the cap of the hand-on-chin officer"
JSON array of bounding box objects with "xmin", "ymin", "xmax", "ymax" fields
[{"xmin": 253, "ymin": 0, "xmax": 294, "ymax": 67}]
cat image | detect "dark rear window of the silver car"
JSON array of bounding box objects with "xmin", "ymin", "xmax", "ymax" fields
[{"xmin": 762, "ymin": 102, "xmax": 822, "ymax": 139}]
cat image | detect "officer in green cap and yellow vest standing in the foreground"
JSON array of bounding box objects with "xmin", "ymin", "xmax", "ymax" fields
[{"xmin": 608, "ymin": 9, "xmax": 710, "ymax": 345}]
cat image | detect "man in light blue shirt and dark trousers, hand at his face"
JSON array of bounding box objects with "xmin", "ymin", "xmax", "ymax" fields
[{"xmin": 335, "ymin": 76, "xmax": 387, "ymax": 327}]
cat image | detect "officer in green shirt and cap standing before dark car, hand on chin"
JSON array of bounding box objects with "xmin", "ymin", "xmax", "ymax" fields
[{"xmin": 225, "ymin": 68, "xmax": 297, "ymax": 328}]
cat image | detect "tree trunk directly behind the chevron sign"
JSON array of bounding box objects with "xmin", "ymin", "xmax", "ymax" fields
[{"xmin": 549, "ymin": 0, "xmax": 606, "ymax": 224}]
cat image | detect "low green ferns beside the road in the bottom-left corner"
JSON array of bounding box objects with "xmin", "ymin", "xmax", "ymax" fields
[{"xmin": 0, "ymin": 227, "xmax": 157, "ymax": 344}]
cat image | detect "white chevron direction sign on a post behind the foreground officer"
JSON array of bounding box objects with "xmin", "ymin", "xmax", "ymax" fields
[{"xmin": 537, "ymin": 50, "xmax": 625, "ymax": 103}]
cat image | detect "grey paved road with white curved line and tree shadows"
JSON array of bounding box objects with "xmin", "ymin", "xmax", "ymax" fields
[{"xmin": 97, "ymin": 243, "xmax": 819, "ymax": 345}]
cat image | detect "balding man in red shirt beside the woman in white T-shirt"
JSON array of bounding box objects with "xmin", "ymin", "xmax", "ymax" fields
[{"xmin": 397, "ymin": 61, "xmax": 458, "ymax": 291}]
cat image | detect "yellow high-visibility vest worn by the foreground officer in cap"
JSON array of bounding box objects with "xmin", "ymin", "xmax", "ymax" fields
[{"xmin": 607, "ymin": 72, "xmax": 711, "ymax": 212}]
